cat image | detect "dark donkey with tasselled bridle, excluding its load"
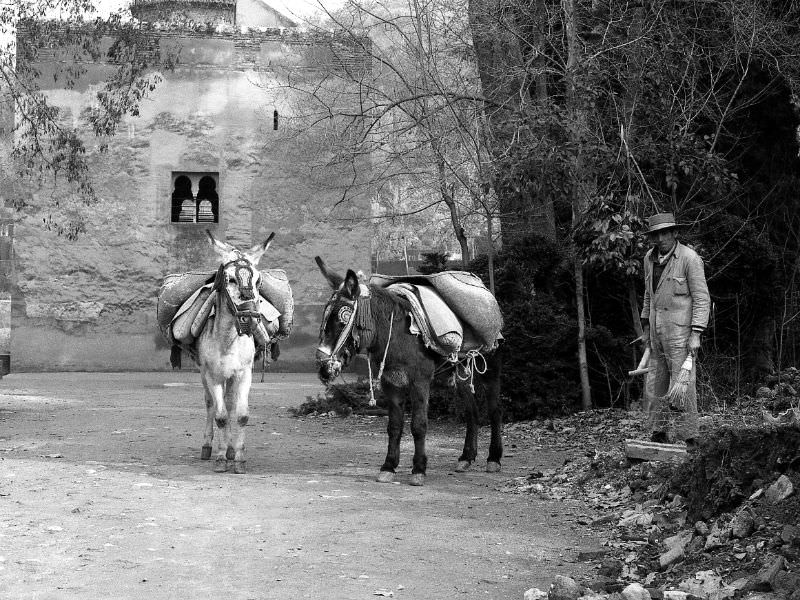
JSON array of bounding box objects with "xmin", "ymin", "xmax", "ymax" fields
[{"xmin": 315, "ymin": 257, "xmax": 503, "ymax": 485}]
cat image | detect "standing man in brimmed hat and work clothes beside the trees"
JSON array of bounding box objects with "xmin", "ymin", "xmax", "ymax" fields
[{"xmin": 641, "ymin": 213, "xmax": 711, "ymax": 448}]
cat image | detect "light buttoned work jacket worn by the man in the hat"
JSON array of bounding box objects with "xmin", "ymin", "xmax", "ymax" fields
[{"xmin": 641, "ymin": 242, "xmax": 711, "ymax": 335}]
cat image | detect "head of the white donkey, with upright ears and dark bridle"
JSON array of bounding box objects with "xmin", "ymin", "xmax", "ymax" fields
[{"xmin": 206, "ymin": 230, "xmax": 275, "ymax": 326}]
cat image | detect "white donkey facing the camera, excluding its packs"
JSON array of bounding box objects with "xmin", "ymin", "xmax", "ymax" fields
[{"xmin": 197, "ymin": 231, "xmax": 275, "ymax": 473}]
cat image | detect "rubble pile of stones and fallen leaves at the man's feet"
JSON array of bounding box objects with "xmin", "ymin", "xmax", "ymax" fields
[{"xmin": 500, "ymin": 406, "xmax": 800, "ymax": 600}]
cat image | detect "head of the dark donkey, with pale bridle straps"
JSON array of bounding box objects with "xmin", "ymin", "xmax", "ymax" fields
[{"xmin": 314, "ymin": 256, "xmax": 361, "ymax": 383}]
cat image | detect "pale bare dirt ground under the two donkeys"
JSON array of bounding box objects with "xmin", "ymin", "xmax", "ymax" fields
[{"xmin": 0, "ymin": 371, "xmax": 599, "ymax": 600}]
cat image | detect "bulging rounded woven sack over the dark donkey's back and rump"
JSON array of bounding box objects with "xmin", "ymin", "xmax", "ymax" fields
[{"xmin": 369, "ymin": 271, "xmax": 503, "ymax": 351}]
